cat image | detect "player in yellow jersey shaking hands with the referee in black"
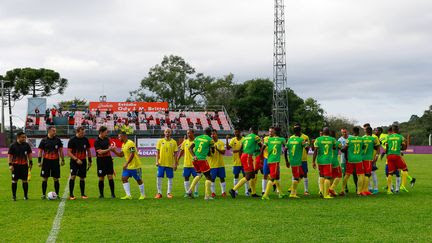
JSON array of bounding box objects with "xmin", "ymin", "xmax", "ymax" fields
[{"xmin": 110, "ymin": 132, "xmax": 145, "ymax": 200}]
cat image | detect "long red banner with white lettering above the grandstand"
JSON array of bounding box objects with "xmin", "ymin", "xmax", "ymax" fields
[{"xmin": 89, "ymin": 102, "xmax": 168, "ymax": 112}]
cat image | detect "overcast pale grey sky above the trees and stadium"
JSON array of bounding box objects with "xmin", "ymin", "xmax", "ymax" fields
[{"xmin": 0, "ymin": 0, "xmax": 432, "ymax": 126}]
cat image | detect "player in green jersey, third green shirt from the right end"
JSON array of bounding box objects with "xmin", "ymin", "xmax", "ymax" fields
[{"xmin": 339, "ymin": 127, "xmax": 364, "ymax": 196}]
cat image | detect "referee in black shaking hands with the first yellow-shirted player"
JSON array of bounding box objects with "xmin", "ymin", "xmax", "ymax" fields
[{"xmin": 94, "ymin": 126, "xmax": 115, "ymax": 198}]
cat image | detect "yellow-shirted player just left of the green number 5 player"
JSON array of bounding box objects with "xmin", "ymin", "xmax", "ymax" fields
[{"xmin": 177, "ymin": 129, "xmax": 199, "ymax": 197}]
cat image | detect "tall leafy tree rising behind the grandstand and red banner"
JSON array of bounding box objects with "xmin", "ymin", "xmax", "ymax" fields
[{"xmin": 128, "ymin": 55, "xmax": 232, "ymax": 108}]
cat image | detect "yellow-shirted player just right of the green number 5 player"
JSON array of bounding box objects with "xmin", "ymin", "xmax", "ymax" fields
[{"xmin": 207, "ymin": 129, "xmax": 226, "ymax": 198}]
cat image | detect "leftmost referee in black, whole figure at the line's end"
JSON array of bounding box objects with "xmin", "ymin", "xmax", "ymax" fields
[{"xmin": 8, "ymin": 132, "xmax": 33, "ymax": 201}]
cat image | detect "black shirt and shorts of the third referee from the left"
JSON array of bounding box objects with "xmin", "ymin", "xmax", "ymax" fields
[{"xmin": 68, "ymin": 136, "xmax": 90, "ymax": 178}]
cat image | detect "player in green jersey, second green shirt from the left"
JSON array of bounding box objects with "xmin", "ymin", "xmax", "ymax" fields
[{"xmin": 229, "ymin": 127, "xmax": 262, "ymax": 198}]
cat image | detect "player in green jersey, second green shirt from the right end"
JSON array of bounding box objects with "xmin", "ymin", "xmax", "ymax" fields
[{"xmin": 359, "ymin": 126, "xmax": 380, "ymax": 196}]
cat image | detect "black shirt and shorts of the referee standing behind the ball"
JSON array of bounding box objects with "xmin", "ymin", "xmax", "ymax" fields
[{"xmin": 39, "ymin": 137, "xmax": 63, "ymax": 178}]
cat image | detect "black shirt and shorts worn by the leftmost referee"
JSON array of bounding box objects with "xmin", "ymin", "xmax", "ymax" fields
[{"xmin": 8, "ymin": 142, "xmax": 32, "ymax": 181}]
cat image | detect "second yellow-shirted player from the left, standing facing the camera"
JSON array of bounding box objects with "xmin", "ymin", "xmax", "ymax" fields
[{"xmin": 155, "ymin": 128, "xmax": 178, "ymax": 199}]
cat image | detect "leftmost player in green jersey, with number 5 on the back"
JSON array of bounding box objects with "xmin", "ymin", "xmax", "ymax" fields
[{"xmin": 187, "ymin": 127, "xmax": 214, "ymax": 200}]
